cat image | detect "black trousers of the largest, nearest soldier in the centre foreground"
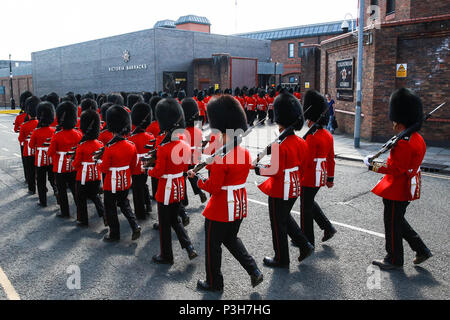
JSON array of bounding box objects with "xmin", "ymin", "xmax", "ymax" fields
[{"xmin": 205, "ymin": 219, "xmax": 258, "ymax": 288}]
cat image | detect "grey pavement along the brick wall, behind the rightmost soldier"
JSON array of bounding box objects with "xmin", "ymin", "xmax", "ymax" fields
[{"xmin": 333, "ymin": 134, "xmax": 450, "ymax": 174}]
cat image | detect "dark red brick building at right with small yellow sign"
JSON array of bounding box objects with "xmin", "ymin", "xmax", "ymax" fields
[{"xmin": 320, "ymin": 0, "xmax": 450, "ymax": 146}]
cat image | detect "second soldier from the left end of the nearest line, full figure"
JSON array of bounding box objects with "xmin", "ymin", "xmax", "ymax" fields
[{"xmin": 29, "ymin": 102, "xmax": 58, "ymax": 207}]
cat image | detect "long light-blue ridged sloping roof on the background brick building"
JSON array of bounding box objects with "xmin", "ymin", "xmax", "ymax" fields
[{"xmin": 235, "ymin": 20, "xmax": 356, "ymax": 40}]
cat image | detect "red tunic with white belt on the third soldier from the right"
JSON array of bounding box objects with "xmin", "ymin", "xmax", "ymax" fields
[{"xmin": 258, "ymin": 135, "xmax": 307, "ymax": 200}]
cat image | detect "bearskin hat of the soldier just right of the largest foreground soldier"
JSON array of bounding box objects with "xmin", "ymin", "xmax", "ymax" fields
[{"xmin": 273, "ymin": 93, "xmax": 304, "ymax": 130}]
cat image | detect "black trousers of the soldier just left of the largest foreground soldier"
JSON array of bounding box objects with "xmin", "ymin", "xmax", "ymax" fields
[{"xmin": 158, "ymin": 202, "xmax": 192, "ymax": 260}]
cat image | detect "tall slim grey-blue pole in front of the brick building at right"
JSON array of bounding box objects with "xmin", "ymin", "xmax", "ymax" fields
[{"xmin": 354, "ymin": 0, "xmax": 364, "ymax": 148}]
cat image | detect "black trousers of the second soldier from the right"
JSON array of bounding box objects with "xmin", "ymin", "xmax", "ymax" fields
[{"xmin": 300, "ymin": 187, "xmax": 332, "ymax": 245}]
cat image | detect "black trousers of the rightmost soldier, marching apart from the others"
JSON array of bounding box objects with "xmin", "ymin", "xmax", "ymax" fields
[{"xmin": 383, "ymin": 199, "xmax": 428, "ymax": 266}]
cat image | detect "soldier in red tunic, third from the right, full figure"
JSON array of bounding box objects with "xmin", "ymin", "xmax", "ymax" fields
[{"xmin": 255, "ymin": 93, "xmax": 314, "ymax": 268}]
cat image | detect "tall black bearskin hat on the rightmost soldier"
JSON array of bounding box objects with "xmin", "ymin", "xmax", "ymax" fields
[{"xmin": 389, "ymin": 88, "xmax": 423, "ymax": 129}]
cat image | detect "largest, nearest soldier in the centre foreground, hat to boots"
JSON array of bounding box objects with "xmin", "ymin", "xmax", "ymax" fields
[{"xmin": 188, "ymin": 95, "xmax": 263, "ymax": 291}]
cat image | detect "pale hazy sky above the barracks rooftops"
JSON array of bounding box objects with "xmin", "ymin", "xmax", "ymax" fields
[{"xmin": 0, "ymin": 0, "xmax": 358, "ymax": 61}]
